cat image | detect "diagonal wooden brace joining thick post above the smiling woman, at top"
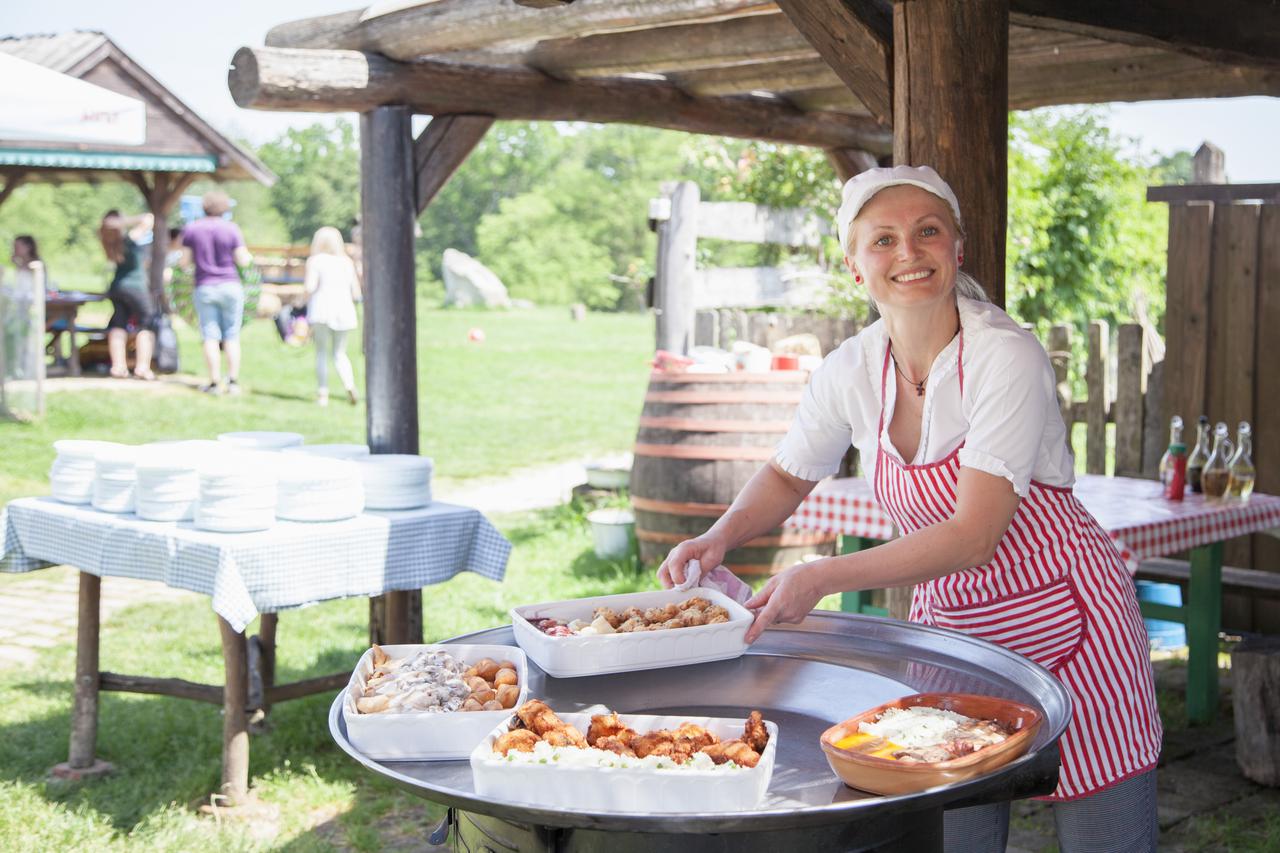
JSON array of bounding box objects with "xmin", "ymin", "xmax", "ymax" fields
[{"xmin": 778, "ymin": 0, "xmax": 893, "ymax": 127}]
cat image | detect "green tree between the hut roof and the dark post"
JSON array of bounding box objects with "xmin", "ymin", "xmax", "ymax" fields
[{"xmin": 257, "ymin": 119, "xmax": 360, "ymax": 243}]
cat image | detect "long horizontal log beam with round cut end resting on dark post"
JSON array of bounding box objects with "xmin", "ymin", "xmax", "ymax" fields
[{"xmin": 227, "ymin": 47, "xmax": 892, "ymax": 154}]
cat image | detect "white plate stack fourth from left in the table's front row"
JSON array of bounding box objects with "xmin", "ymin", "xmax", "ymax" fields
[{"xmin": 196, "ymin": 453, "xmax": 276, "ymax": 533}]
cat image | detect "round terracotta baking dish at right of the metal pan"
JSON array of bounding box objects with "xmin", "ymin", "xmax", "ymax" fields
[{"xmin": 822, "ymin": 693, "xmax": 1044, "ymax": 795}]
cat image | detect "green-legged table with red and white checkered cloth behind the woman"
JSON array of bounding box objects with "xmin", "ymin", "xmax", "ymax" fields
[{"xmin": 786, "ymin": 474, "xmax": 1280, "ymax": 721}]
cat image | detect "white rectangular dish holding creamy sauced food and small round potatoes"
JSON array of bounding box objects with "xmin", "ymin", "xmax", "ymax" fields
[{"xmin": 342, "ymin": 643, "xmax": 529, "ymax": 761}]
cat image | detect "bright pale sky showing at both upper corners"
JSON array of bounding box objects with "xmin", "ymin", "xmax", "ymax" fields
[{"xmin": 10, "ymin": 0, "xmax": 1280, "ymax": 183}]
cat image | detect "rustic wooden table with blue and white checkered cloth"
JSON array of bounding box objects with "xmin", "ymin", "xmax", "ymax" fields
[{"xmin": 0, "ymin": 497, "xmax": 511, "ymax": 799}]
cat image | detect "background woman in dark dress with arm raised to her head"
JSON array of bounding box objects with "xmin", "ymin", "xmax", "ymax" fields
[{"xmin": 97, "ymin": 210, "xmax": 159, "ymax": 380}]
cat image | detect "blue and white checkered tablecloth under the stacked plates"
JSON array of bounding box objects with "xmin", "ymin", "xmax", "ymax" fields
[{"xmin": 0, "ymin": 497, "xmax": 511, "ymax": 630}]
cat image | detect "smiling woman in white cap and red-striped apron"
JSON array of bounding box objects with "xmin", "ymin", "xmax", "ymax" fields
[{"xmin": 659, "ymin": 167, "xmax": 1162, "ymax": 852}]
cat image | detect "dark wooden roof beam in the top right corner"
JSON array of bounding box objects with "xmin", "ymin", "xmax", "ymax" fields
[{"xmin": 1009, "ymin": 0, "xmax": 1280, "ymax": 68}]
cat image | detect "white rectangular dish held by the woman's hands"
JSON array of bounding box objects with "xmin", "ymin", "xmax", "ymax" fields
[{"xmin": 511, "ymin": 588, "xmax": 754, "ymax": 679}]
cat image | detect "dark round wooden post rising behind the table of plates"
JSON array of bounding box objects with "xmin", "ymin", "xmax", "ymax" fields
[{"xmin": 360, "ymin": 106, "xmax": 422, "ymax": 643}]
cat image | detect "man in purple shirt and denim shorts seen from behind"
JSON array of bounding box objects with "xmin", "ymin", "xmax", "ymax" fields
[{"xmin": 182, "ymin": 190, "xmax": 253, "ymax": 394}]
